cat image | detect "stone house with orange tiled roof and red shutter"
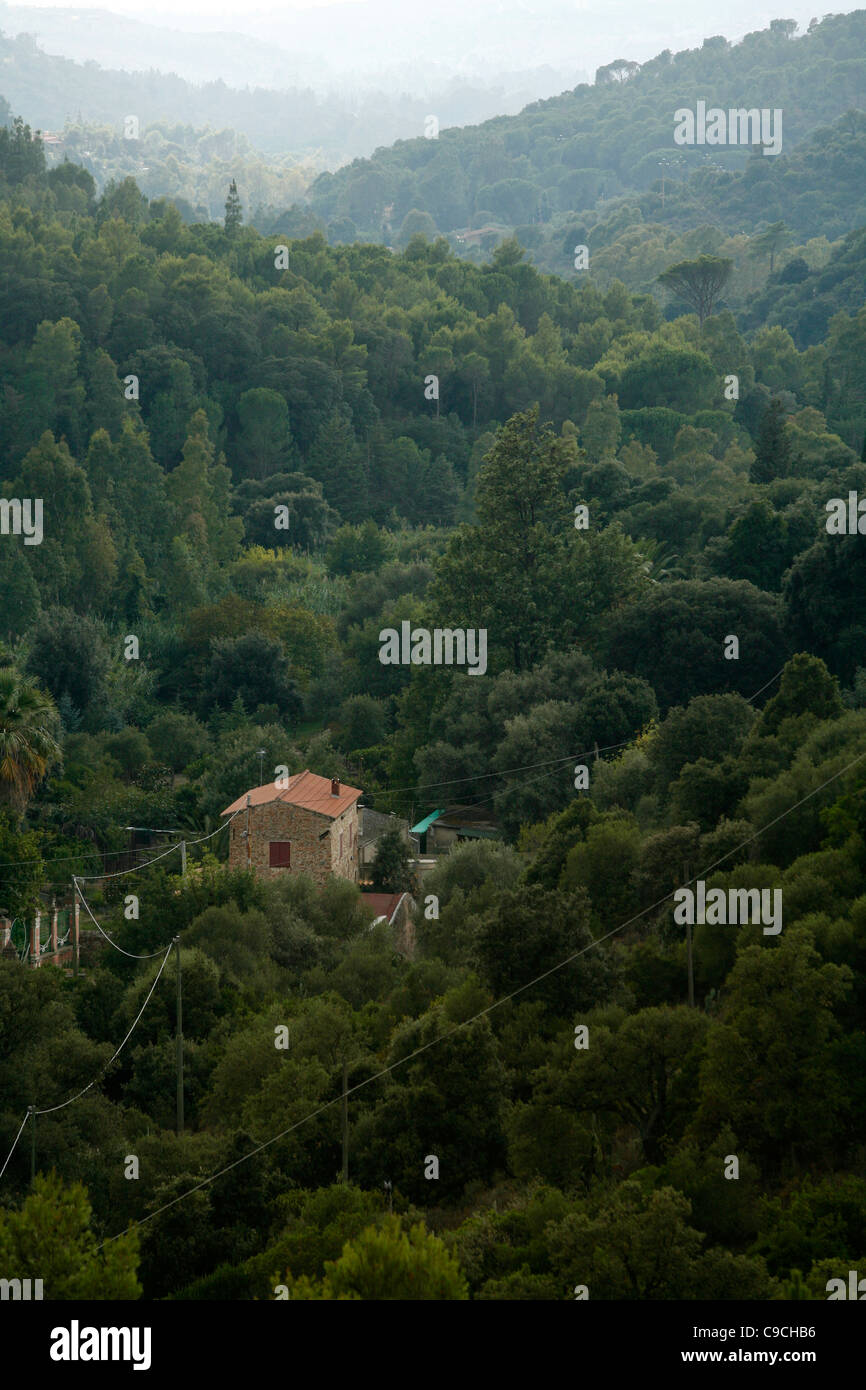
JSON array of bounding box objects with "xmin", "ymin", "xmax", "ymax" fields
[{"xmin": 222, "ymin": 769, "xmax": 361, "ymax": 887}]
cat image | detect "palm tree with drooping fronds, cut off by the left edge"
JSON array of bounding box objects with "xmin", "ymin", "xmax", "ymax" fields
[{"xmin": 0, "ymin": 666, "xmax": 60, "ymax": 815}]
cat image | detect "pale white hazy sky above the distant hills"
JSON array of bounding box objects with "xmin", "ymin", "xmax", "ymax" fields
[{"xmin": 8, "ymin": 0, "xmax": 863, "ymax": 94}]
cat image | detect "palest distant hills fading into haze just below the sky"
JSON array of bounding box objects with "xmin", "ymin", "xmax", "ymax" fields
[{"xmin": 0, "ymin": 23, "xmax": 578, "ymax": 168}]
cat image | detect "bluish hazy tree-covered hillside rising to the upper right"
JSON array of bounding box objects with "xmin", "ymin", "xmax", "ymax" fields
[{"xmin": 310, "ymin": 10, "xmax": 866, "ymax": 274}]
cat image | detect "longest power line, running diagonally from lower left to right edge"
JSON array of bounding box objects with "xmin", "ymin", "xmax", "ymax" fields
[{"xmin": 99, "ymin": 751, "xmax": 866, "ymax": 1250}]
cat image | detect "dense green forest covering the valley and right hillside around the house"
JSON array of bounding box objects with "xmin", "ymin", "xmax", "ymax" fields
[{"xmin": 0, "ymin": 13, "xmax": 866, "ymax": 1300}]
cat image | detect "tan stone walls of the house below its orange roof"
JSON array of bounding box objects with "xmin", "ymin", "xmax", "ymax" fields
[{"xmin": 228, "ymin": 801, "xmax": 357, "ymax": 887}]
